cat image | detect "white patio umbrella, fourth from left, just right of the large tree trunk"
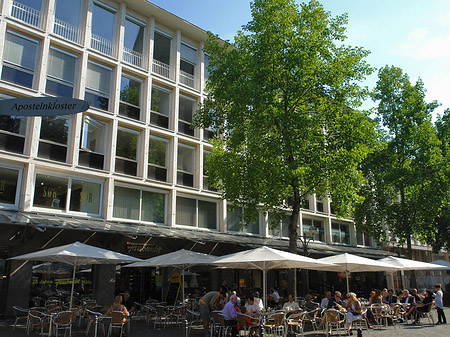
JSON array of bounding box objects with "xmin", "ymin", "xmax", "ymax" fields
[{"xmin": 319, "ymin": 253, "xmax": 402, "ymax": 293}]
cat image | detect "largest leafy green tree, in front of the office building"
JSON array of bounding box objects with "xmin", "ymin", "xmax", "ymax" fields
[{"xmin": 195, "ymin": 0, "xmax": 374, "ymax": 288}]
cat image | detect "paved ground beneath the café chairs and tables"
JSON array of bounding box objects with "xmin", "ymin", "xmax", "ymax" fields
[{"xmin": 0, "ymin": 308, "xmax": 450, "ymax": 337}]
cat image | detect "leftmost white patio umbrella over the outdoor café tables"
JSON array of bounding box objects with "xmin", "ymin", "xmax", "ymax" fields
[{"xmin": 9, "ymin": 241, "xmax": 142, "ymax": 309}]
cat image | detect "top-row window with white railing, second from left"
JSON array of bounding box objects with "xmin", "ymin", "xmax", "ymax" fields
[{"xmin": 53, "ymin": 0, "xmax": 83, "ymax": 43}]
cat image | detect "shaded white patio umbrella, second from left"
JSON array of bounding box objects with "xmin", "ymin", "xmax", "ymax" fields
[{"xmin": 123, "ymin": 249, "xmax": 217, "ymax": 304}]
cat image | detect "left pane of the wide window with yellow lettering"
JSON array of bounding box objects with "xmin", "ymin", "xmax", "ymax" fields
[{"xmin": 33, "ymin": 174, "xmax": 68, "ymax": 210}]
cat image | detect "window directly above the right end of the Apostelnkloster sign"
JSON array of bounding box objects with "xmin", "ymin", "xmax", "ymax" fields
[{"xmin": 45, "ymin": 48, "xmax": 77, "ymax": 97}]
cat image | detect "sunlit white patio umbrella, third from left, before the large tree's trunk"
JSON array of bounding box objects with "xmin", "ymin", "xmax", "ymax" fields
[{"xmin": 213, "ymin": 246, "xmax": 334, "ymax": 306}]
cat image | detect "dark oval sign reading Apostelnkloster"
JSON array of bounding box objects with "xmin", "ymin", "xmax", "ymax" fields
[{"xmin": 0, "ymin": 97, "xmax": 89, "ymax": 116}]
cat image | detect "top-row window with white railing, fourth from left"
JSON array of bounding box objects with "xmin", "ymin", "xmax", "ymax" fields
[{"xmin": 123, "ymin": 17, "xmax": 145, "ymax": 68}]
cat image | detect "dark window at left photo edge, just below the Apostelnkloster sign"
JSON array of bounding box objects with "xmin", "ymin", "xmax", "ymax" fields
[{"xmin": 0, "ymin": 97, "xmax": 27, "ymax": 153}]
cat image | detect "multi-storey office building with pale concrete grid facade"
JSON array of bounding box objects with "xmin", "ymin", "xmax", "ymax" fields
[{"xmin": 0, "ymin": 0, "xmax": 444, "ymax": 311}]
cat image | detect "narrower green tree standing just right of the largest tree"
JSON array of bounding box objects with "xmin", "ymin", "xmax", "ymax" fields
[{"xmin": 355, "ymin": 66, "xmax": 446, "ymax": 272}]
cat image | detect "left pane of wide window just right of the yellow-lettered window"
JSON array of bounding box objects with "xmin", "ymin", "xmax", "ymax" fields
[{"xmin": 113, "ymin": 186, "xmax": 141, "ymax": 220}]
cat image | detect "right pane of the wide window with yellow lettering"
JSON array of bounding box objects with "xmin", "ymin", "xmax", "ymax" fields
[{"xmin": 70, "ymin": 179, "xmax": 101, "ymax": 214}]
